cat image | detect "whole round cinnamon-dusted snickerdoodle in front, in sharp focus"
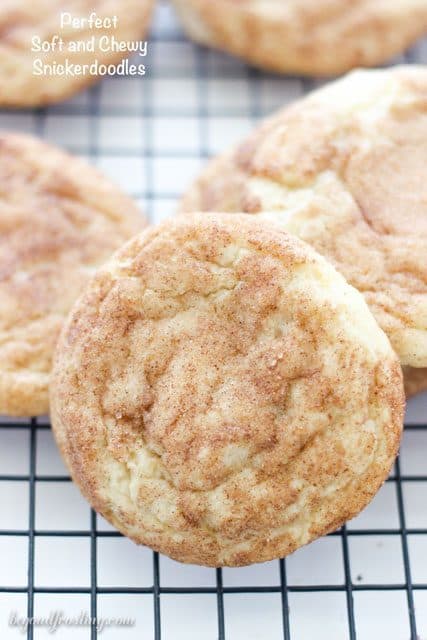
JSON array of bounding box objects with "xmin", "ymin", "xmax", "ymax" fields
[{"xmin": 51, "ymin": 214, "xmax": 404, "ymax": 566}]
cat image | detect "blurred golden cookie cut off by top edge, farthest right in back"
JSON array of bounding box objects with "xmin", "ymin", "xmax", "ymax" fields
[{"xmin": 174, "ymin": 0, "xmax": 427, "ymax": 75}]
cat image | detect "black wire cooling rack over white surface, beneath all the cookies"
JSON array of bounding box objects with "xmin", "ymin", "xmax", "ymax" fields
[{"xmin": 0, "ymin": 3, "xmax": 427, "ymax": 640}]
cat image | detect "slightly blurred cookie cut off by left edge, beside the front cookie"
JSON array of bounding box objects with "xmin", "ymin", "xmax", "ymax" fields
[{"xmin": 0, "ymin": 133, "xmax": 143, "ymax": 416}]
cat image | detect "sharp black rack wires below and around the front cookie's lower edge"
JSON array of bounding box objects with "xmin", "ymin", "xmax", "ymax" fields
[{"xmin": 0, "ymin": 418, "xmax": 427, "ymax": 640}]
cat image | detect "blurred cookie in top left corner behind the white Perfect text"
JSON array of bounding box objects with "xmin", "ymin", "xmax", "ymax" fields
[{"xmin": 0, "ymin": 0, "xmax": 154, "ymax": 107}]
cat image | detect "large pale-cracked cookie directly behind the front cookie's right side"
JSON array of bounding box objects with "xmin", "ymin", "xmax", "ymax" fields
[{"xmin": 182, "ymin": 67, "xmax": 427, "ymax": 367}]
